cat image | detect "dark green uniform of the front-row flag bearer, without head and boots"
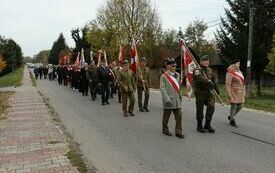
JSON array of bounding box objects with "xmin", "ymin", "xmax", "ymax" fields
[{"xmin": 193, "ymin": 67, "xmax": 217, "ymax": 121}]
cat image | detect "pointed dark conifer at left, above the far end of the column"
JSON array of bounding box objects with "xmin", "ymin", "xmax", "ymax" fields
[{"xmin": 48, "ymin": 33, "xmax": 68, "ymax": 64}]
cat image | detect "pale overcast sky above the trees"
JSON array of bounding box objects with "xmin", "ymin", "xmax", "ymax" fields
[{"xmin": 0, "ymin": 0, "xmax": 227, "ymax": 56}]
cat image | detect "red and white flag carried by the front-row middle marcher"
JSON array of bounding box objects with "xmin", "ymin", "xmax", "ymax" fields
[{"xmin": 180, "ymin": 39, "xmax": 196, "ymax": 98}]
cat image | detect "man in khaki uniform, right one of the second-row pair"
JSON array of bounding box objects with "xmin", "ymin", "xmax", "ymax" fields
[{"xmin": 137, "ymin": 57, "xmax": 151, "ymax": 112}]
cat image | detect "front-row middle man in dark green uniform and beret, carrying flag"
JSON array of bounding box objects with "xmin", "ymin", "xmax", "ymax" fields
[{"xmin": 193, "ymin": 55, "xmax": 219, "ymax": 133}]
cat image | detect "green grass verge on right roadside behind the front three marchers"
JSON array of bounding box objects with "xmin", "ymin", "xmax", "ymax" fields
[{"xmin": 181, "ymin": 85, "xmax": 275, "ymax": 113}]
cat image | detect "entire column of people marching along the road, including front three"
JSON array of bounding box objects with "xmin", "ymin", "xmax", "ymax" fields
[{"xmin": 34, "ymin": 55, "xmax": 245, "ymax": 138}]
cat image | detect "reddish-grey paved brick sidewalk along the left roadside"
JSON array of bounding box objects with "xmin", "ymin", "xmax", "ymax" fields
[{"xmin": 0, "ymin": 68, "xmax": 78, "ymax": 173}]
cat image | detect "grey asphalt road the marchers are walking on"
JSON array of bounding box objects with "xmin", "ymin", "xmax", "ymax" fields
[{"xmin": 34, "ymin": 76, "xmax": 275, "ymax": 173}]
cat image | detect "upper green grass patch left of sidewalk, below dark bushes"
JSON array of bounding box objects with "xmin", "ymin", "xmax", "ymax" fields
[{"xmin": 0, "ymin": 67, "xmax": 24, "ymax": 88}]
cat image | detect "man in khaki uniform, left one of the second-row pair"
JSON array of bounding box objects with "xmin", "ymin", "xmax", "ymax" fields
[{"xmin": 118, "ymin": 60, "xmax": 136, "ymax": 117}]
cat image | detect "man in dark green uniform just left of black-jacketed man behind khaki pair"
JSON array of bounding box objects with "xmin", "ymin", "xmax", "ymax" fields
[{"xmin": 88, "ymin": 61, "xmax": 98, "ymax": 101}]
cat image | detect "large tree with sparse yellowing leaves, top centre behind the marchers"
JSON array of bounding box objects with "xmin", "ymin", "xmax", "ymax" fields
[{"xmin": 87, "ymin": 0, "xmax": 161, "ymax": 63}]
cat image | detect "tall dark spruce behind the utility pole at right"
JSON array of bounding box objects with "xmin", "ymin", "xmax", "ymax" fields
[{"xmin": 216, "ymin": 0, "xmax": 275, "ymax": 94}]
